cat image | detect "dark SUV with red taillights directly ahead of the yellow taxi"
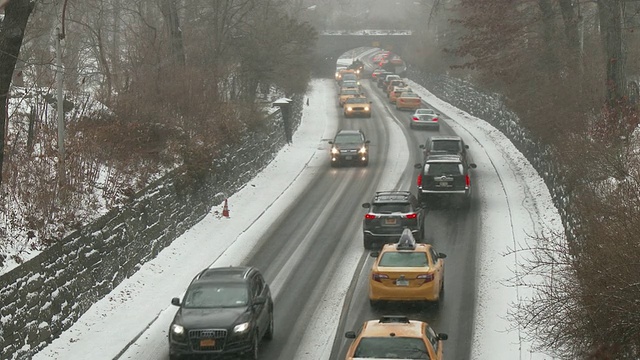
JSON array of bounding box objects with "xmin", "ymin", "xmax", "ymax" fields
[{"xmin": 362, "ymin": 191, "xmax": 425, "ymax": 249}]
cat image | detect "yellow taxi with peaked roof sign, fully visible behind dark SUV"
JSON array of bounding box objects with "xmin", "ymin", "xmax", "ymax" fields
[{"xmin": 369, "ymin": 229, "xmax": 447, "ymax": 307}]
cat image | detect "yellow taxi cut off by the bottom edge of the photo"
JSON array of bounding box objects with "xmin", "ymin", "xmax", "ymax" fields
[{"xmin": 344, "ymin": 315, "xmax": 449, "ymax": 360}]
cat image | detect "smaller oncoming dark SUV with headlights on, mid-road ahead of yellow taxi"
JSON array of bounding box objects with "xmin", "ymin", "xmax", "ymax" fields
[{"xmin": 329, "ymin": 130, "xmax": 369, "ymax": 166}]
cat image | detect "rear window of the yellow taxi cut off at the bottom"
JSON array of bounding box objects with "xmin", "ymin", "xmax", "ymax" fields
[{"xmin": 353, "ymin": 337, "xmax": 431, "ymax": 359}]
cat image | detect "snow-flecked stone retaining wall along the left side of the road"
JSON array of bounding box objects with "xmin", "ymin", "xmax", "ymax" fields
[{"xmin": 0, "ymin": 97, "xmax": 302, "ymax": 360}]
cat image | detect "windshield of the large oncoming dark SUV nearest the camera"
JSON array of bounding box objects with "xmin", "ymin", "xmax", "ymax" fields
[{"xmin": 183, "ymin": 283, "xmax": 249, "ymax": 308}]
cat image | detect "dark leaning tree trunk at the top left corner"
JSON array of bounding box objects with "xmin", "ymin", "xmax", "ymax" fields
[{"xmin": 0, "ymin": 0, "xmax": 34, "ymax": 184}]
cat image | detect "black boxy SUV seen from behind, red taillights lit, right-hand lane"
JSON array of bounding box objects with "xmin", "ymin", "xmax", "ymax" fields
[{"xmin": 415, "ymin": 155, "xmax": 476, "ymax": 206}]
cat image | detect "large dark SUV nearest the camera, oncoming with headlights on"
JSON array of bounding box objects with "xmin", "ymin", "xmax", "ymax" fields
[{"xmin": 169, "ymin": 267, "xmax": 273, "ymax": 360}]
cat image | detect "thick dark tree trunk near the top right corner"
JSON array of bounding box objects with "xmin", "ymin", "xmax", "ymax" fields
[{"xmin": 598, "ymin": 0, "xmax": 626, "ymax": 107}]
